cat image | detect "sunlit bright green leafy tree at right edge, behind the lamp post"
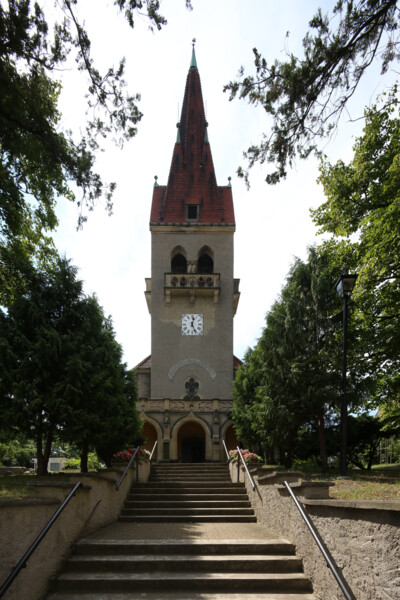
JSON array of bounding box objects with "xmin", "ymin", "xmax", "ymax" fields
[{"xmin": 312, "ymin": 95, "xmax": 400, "ymax": 422}]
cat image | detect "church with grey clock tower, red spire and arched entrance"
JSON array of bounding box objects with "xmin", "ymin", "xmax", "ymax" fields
[{"xmin": 136, "ymin": 46, "xmax": 240, "ymax": 462}]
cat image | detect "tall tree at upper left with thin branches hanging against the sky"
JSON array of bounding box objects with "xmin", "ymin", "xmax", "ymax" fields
[{"xmin": 0, "ymin": 0, "xmax": 190, "ymax": 305}]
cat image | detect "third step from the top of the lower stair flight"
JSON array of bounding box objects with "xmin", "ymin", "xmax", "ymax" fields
[{"xmin": 53, "ymin": 570, "xmax": 311, "ymax": 593}]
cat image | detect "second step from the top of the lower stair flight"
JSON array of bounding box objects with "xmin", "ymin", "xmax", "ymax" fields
[{"xmin": 66, "ymin": 554, "xmax": 302, "ymax": 573}]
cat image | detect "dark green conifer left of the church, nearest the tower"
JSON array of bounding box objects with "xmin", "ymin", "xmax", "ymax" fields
[{"xmin": 60, "ymin": 297, "xmax": 142, "ymax": 472}]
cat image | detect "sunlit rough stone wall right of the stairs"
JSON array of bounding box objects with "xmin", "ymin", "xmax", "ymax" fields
[{"xmin": 230, "ymin": 464, "xmax": 400, "ymax": 600}]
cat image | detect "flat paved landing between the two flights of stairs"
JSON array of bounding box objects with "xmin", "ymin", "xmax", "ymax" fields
[{"xmin": 87, "ymin": 523, "xmax": 281, "ymax": 541}]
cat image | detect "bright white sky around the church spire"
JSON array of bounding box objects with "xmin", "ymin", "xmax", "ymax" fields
[{"xmin": 50, "ymin": 0, "xmax": 389, "ymax": 367}]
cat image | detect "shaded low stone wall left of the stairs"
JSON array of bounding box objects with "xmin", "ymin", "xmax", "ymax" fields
[{"xmin": 0, "ymin": 462, "xmax": 150, "ymax": 600}]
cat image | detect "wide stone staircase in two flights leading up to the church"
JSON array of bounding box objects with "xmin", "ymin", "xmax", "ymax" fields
[{"xmin": 47, "ymin": 464, "xmax": 315, "ymax": 600}]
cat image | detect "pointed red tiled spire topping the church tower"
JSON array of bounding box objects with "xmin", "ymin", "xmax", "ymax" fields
[{"xmin": 150, "ymin": 48, "xmax": 235, "ymax": 225}]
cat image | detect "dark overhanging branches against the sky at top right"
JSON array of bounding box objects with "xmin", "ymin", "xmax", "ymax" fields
[{"xmin": 224, "ymin": 0, "xmax": 399, "ymax": 184}]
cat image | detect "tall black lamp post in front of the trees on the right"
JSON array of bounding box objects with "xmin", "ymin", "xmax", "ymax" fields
[{"xmin": 335, "ymin": 273, "xmax": 358, "ymax": 477}]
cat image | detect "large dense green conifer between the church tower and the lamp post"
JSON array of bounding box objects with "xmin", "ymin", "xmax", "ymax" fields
[{"xmin": 232, "ymin": 241, "xmax": 372, "ymax": 468}]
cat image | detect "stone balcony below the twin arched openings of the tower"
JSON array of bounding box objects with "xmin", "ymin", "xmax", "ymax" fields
[{"xmin": 164, "ymin": 273, "xmax": 221, "ymax": 306}]
